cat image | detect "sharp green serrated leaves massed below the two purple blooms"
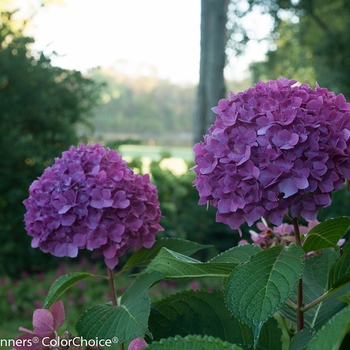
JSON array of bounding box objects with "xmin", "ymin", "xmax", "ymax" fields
[{"xmin": 45, "ymin": 217, "xmax": 350, "ymax": 350}]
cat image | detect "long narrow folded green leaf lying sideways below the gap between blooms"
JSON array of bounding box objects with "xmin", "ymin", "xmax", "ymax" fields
[{"xmin": 146, "ymin": 248, "xmax": 237, "ymax": 279}]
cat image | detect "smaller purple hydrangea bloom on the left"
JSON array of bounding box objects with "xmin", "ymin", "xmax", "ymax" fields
[{"xmin": 23, "ymin": 144, "xmax": 162, "ymax": 269}]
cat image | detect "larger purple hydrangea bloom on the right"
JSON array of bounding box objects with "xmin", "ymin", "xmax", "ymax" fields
[{"xmin": 193, "ymin": 78, "xmax": 350, "ymax": 229}]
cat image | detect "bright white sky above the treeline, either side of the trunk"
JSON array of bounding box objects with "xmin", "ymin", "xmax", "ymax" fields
[{"xmin": 13, "ymin": 0, "xmax": 266, "ymax": 84}]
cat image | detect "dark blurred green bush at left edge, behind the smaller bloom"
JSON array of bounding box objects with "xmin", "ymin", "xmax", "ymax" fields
[{"xmin": 0, "ymin": 12, "xmax": 98, "ymax": 275}]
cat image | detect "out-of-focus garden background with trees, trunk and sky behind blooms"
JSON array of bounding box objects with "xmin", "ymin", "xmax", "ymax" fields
[{"xmin": 0, "ymin": 0, "xmax": 350, "ymax": 335}]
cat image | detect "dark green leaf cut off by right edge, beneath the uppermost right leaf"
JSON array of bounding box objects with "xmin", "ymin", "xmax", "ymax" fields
[{"xmin": 328, "ymin": 242, "xmax": 350, "ymax": 288}]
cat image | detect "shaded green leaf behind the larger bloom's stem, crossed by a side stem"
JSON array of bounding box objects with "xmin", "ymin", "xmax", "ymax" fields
[{"xmin": 280, "ymin": 249, "xmax": 350, "ymax": 330}]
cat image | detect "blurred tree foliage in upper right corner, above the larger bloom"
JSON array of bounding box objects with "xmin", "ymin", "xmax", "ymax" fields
[{"xmin": 243, "ymin": 0, "xmax": 350, "ymax": 98}]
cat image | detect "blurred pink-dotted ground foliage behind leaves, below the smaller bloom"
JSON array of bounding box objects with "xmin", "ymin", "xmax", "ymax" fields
[{"xmin": 0, "ymin": 259, "xmax": 215, "ymax": 342}]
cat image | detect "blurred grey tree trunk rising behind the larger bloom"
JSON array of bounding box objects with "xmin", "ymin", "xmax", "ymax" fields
[{"xmin": 194, "ymin": 0, "xmax": 229, "ymax": 143}]
